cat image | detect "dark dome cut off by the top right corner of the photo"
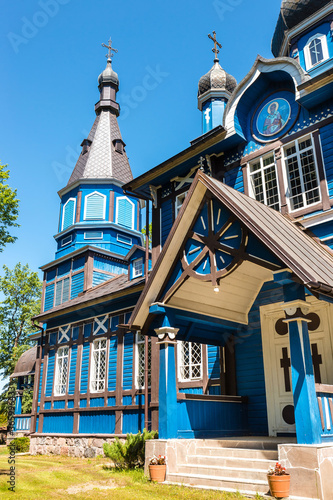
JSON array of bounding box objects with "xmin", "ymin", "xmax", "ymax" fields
[{"xmin": 272, "ymin": 0, "xmax": 329, "ymax": 57}]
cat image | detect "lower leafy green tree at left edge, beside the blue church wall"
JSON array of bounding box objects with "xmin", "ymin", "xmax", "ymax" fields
[{"xmin": 0, "ymin": 263, "xmax": 42, "ymax": 378}]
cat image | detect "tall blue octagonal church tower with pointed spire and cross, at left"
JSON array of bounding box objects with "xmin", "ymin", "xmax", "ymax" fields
[{"xmin": 42, "ymin": 40, "xmax": 143, "ymax": 310}]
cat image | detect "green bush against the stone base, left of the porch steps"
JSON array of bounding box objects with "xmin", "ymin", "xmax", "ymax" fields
[{"xmin": 103, "ymin": 429, "xmax": 158, "ymax": 469}]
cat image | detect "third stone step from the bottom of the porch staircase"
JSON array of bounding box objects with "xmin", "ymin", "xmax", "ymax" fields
[{"xmin": 187, "ymin": 455, "xmax": 277, "ymax": 472}]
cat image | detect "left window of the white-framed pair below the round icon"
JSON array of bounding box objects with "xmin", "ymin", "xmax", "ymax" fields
[{"xmin": 249, "ymin": 154, "xmax": 280, "ymax": 210}]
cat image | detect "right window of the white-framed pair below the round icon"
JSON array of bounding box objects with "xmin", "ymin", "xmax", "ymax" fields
[{"xmin": 283, "ymin": 136, "xmax": 320, "ymax": 210}]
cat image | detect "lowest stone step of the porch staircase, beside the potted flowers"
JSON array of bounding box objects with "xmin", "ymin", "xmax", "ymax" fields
[{"xmin": 166, "ymin": 473, "xmax": 269, "ymax": 495}]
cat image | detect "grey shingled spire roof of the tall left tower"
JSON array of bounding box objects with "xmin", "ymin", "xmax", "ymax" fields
[{"xmin": 67, "ymin": 110, "xmax": 133, "ymax": 186}]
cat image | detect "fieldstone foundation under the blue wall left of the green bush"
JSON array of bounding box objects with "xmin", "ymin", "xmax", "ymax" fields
[{"xmin": 30, "ymin": 436, "xmax": 118, "ymax": 458}]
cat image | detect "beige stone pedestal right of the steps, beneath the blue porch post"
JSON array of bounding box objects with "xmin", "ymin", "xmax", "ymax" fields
[{"xmin": 278, "ymin": 443, "xmax": 333, "ymax": 500}]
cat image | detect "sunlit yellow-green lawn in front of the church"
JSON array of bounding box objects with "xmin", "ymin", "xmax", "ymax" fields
[{"xmin": 0, "ymin": 447, "xmax": 260, "ymax": 500}]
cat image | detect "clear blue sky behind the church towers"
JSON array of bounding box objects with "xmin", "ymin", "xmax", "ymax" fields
[{"xmin": 0, "ymin": 0, "xmax": 280, "ymax": 278}]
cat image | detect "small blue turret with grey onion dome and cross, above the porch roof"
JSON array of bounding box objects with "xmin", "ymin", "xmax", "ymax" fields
[{"xmin": 198, "ymin": 31, "xmax": 237, "ymax": 134}]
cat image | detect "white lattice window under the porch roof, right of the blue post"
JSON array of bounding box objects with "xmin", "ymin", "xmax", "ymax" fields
[{"xmin": 178, "ymin": 342, "xmax": 202, "ymax": 381}]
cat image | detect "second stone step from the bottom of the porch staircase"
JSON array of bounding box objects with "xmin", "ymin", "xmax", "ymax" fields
[{"xmin": 177, "ymin": 464, "xmax": 267, "ymax": 483}]
